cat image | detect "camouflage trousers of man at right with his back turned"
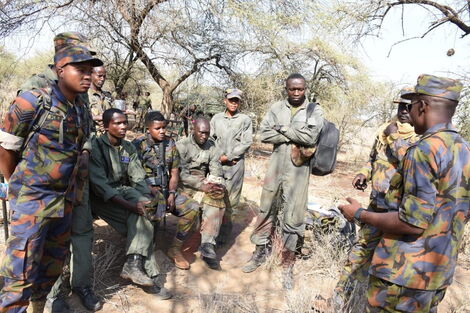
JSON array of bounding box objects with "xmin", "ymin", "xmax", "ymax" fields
[{"xmin": 366, "ymin": 276, "xmax": 446, "ymax": 313}]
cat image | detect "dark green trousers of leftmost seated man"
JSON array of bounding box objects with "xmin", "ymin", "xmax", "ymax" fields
[{"xmin": 90, "ymin": 186, "xmax": 160, "ymax": 277}]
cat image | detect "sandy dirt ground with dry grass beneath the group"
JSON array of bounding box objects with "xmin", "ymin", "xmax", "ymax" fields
[{"xmin": 1, "ymin": 150, "xmax": 470, "ymax": 313}]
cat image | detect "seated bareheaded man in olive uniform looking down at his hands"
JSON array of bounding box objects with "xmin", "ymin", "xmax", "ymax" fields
[{"xmin": 176, "ymin": 118, "xmax": 225, "ymax": 269}]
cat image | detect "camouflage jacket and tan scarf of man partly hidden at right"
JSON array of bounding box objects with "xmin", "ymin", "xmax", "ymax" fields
[{"xmin": 356, "ymin": 122, "xmax": 419, "ymax": 210}]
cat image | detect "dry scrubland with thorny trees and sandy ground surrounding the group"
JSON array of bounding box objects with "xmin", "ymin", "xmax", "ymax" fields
[{"xmin": 0, "ymin": 0, "xmax": 470, "ymax": 313}]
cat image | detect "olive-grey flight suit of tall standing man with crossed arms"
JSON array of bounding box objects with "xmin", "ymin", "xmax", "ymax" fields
[{"xmin": 251, "ymin": 100, "xmax": 323, "ymax": 251}]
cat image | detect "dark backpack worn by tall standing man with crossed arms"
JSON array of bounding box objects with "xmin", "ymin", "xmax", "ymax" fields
[{"xmin": 307, "ymin": 102, "xmax": 339, "ymax": 176}]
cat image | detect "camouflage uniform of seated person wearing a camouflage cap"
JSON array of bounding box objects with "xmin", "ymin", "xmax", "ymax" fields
[{"xmin": 133, "ymin": 134, "xmax": 199, "ymax": 241}]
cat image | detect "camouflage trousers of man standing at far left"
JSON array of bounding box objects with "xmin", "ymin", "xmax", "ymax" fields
[{"xmin": 0, "ymin": 206, "xmax": 72, "ymax": 312}]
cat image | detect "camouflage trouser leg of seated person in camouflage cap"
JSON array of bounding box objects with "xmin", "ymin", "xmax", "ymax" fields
[{"xmin": 171, "ymin": 193, "xmax": 200, "ymax": 241}]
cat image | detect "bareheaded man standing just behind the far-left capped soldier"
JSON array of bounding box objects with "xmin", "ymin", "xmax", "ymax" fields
[{"xmin": 88, "ymin": 66, "xmax": 113, "ymax": 133}]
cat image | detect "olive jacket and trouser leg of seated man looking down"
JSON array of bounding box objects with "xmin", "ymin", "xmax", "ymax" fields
[{"xmin": 176, "ymin": 135, "xmax": 225, "ymax": 245}]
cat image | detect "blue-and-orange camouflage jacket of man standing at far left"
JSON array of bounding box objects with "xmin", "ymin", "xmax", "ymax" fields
[{"xmin": 0, "ymin": 84, "xmax": 89, "ymax": 217}]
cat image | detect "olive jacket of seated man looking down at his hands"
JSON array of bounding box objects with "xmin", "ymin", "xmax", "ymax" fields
[{"xmin": 176, "ymin": 135, "xmax": 223, "ymax": 192}]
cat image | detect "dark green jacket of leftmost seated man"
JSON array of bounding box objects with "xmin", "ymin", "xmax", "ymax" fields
[{"xmin": 90, "ymin": 133, "xmax": 150, "ymax": 201}]
